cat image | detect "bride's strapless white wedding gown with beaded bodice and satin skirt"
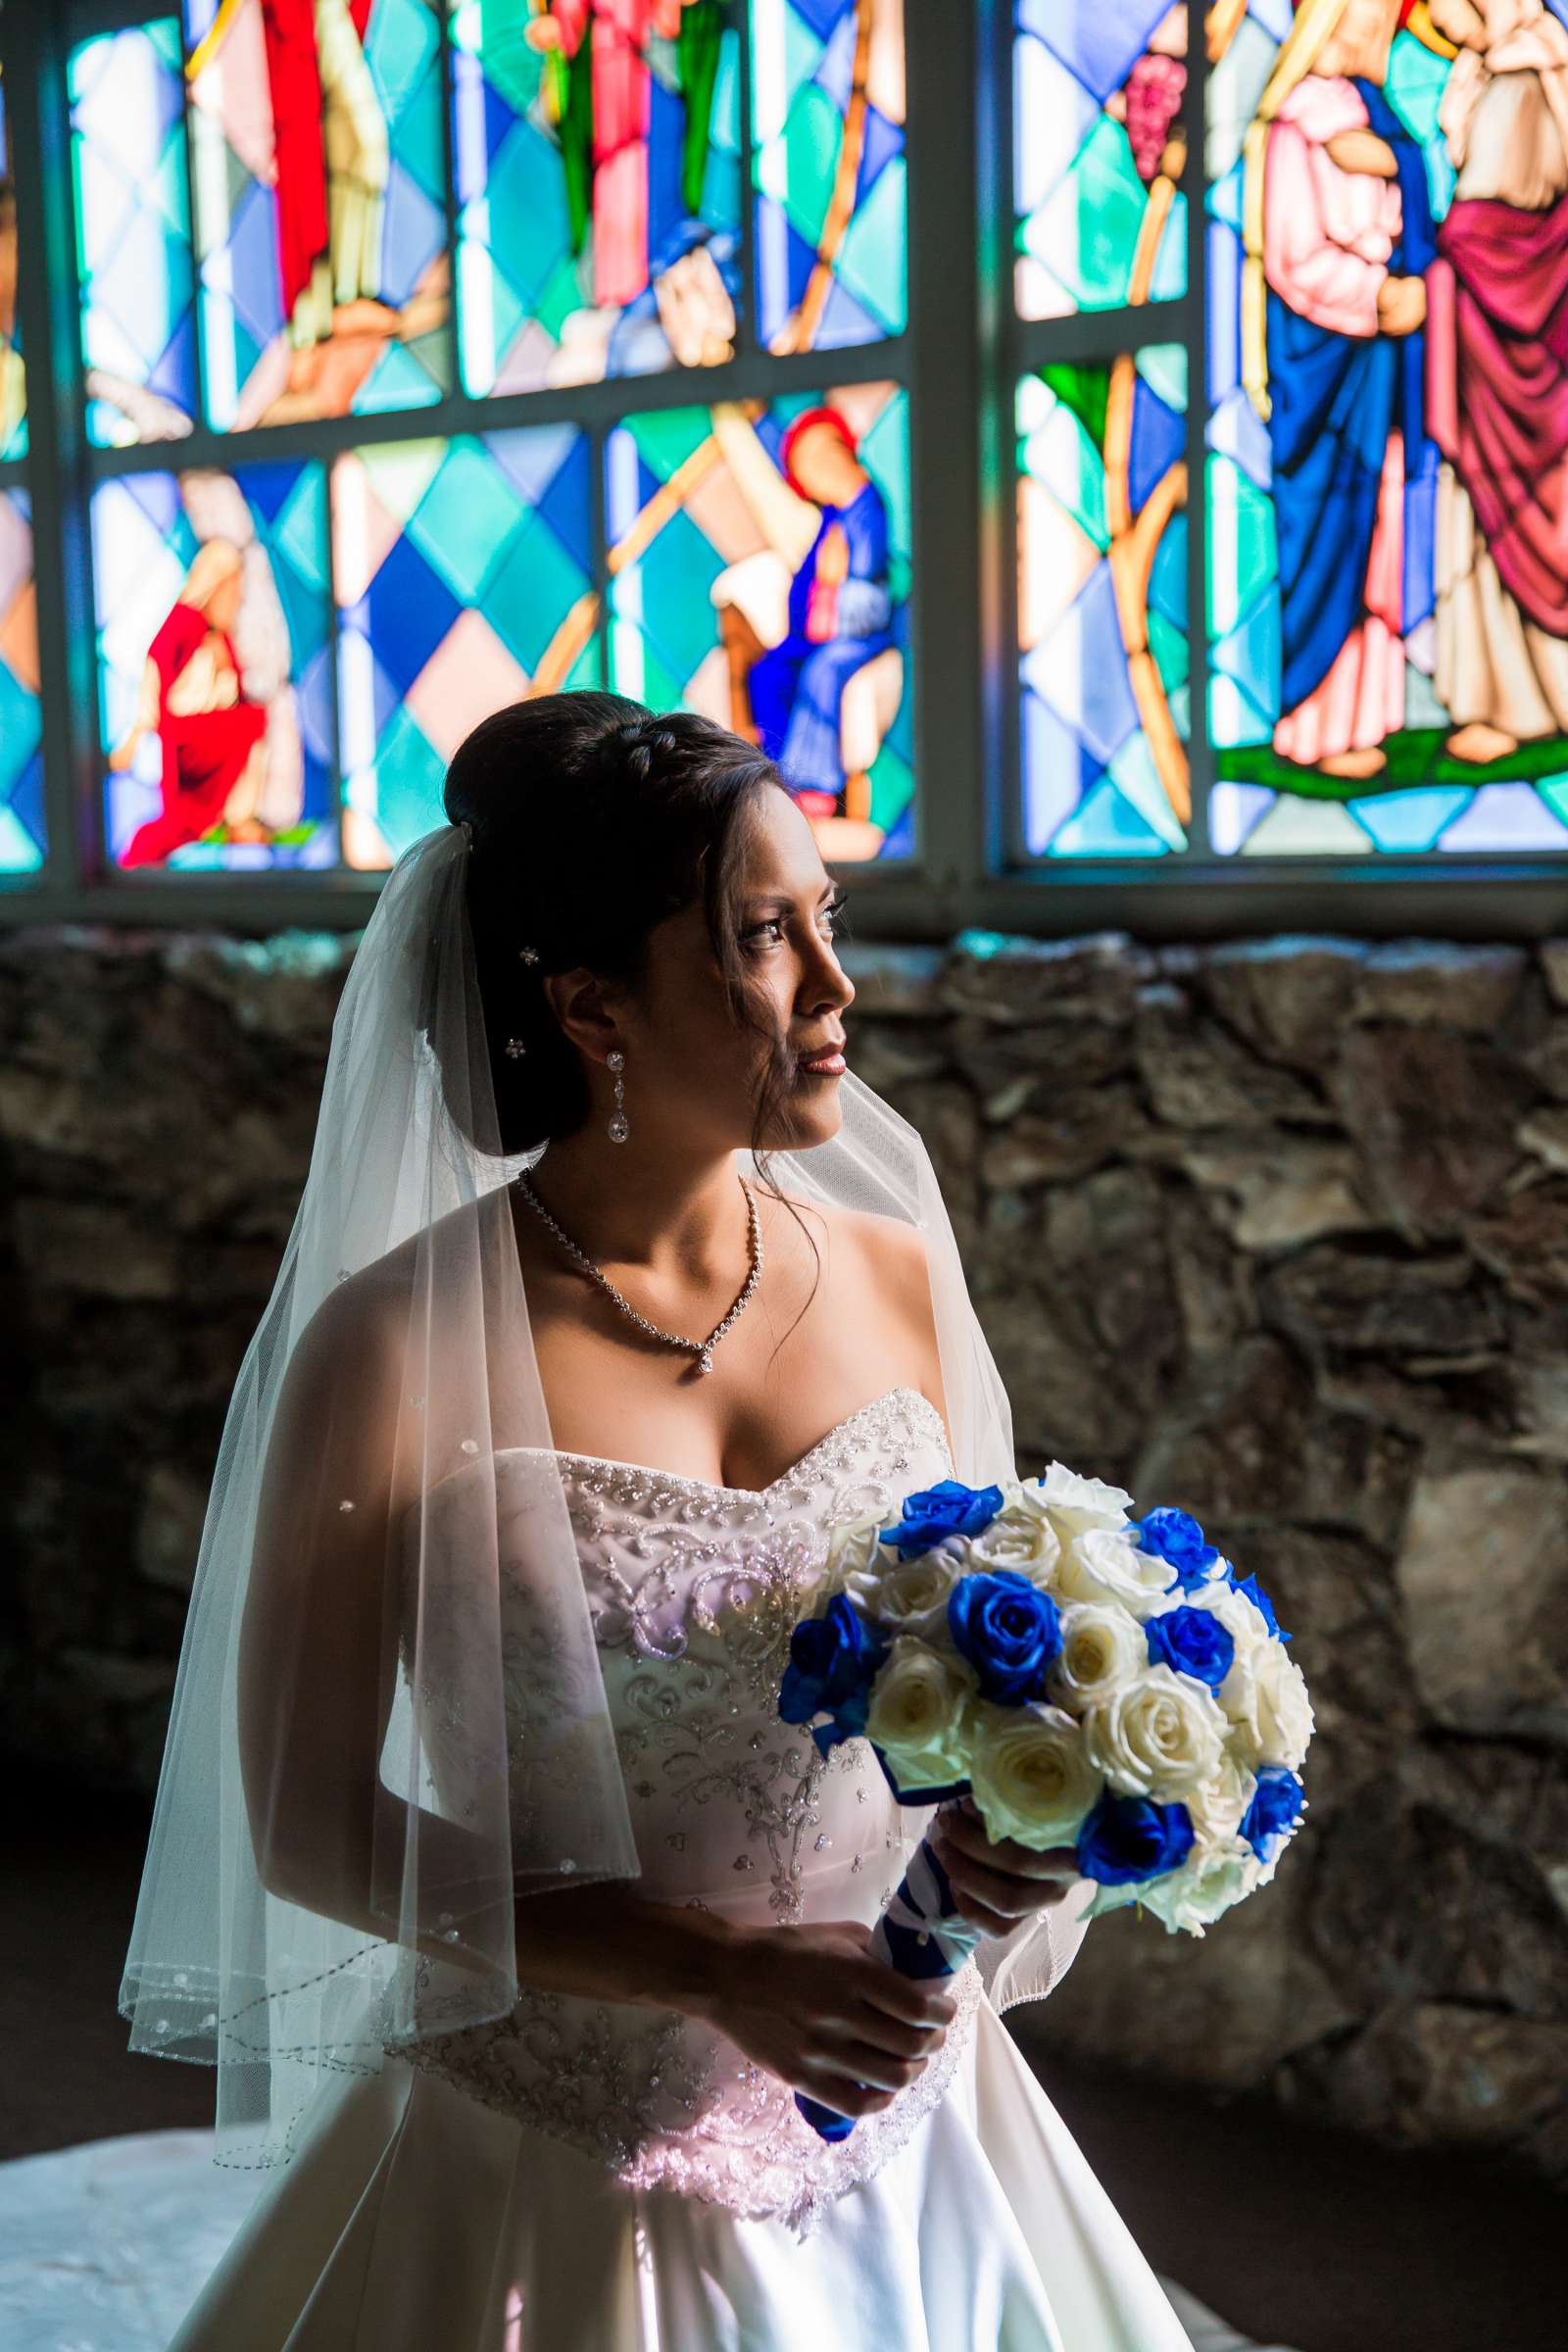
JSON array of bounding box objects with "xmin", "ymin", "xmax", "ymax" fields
[{"xmin": 170, "ymin": 1388, "xmax": 1190, "ymax": 2352}]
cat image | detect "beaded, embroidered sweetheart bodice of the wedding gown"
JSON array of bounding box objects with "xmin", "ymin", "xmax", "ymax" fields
[{"xmin": 400, "ymin": 1388, "xmax": 980, "ymax": 2232}]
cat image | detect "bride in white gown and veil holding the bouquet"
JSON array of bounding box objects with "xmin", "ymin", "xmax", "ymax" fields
[{"xmin": 120, "ymin": 692, "xmax": 1190, "ymax": 2352}]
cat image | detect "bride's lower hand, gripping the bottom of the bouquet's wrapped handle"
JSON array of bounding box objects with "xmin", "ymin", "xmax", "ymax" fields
[{"xmin": 701, "ymin": 1919, "xmax": 956, "ymax": 2117}]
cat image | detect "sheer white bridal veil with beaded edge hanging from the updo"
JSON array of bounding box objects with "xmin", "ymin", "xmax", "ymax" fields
[{"xmin": 120, "ymin": 825, "xmax": 1044, "ymax": 2166}]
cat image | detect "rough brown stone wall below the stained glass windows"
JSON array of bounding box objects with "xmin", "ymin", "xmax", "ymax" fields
[{"xmin": 0, "ymin": 929, "xmax": 1568, "ymax": 2180}]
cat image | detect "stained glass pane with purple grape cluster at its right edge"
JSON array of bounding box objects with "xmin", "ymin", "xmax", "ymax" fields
[{"xmin": 1013, "ymin": 0, "xmax": 1187, "ymax": 318}]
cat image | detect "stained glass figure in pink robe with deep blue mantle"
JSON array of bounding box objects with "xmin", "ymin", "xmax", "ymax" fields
[{"xmin": 1242, "ymin": 0, "xmax": 1437, "ymax": 778}]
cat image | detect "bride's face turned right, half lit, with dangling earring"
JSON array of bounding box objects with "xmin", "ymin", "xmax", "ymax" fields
[{"xmin": 625, "ymin": 788, "xmax": 856, "ymax": 1151}]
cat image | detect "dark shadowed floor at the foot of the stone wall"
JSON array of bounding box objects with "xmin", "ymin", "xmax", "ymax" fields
[{"xmin": 0, "ymin": 1776, "xmax": 1568, "ymax": 2352}]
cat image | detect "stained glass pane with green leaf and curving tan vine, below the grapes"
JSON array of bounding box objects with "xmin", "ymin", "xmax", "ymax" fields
[{"xmin": 1018, "ymin": 343, "xmax": 1190, "ymax": 858}]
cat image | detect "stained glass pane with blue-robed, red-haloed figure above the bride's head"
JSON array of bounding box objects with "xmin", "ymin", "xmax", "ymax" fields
[{"xmin": 604, "ymin": 383, "xmax": 914, "ymax": 858}]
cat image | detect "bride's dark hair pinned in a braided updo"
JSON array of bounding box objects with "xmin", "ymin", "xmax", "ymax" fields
[{"xmin": 442, "ymin": 692, "xmax": 780, "ymax": 1154}]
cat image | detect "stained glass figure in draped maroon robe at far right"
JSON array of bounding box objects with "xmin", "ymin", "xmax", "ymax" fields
[{"xmin": 1429, "ymin": 0, "xmax": 1568, "ymax": 760}]
